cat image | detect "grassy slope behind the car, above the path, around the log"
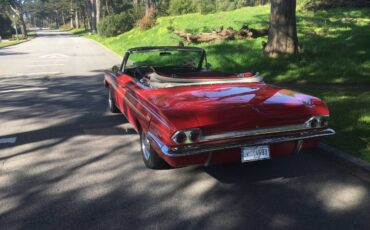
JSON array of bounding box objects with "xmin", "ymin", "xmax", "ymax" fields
[{"xmin": 80, "ymin": 6, "xmax": 370, "ymax": 84}]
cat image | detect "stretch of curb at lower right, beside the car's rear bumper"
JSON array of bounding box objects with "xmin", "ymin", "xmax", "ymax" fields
[{"xmin": 318, "ymin": 143, "xmax": 370, "ymax": 173}]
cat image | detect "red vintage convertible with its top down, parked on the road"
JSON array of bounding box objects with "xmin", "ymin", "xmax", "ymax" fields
[{"xmin": 104, "ymin": 47, "xmax": 335, "ymax": 169}]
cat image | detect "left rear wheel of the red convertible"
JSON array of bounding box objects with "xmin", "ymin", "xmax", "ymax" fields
[{"xmin": 140, "ymin": 131, "xmax": 168, "ymax": 169}]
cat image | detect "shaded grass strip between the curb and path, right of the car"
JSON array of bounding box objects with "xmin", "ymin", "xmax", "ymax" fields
[{"xmin": 307, "ymin": 90, "xmax": 370, "ymax": 162}]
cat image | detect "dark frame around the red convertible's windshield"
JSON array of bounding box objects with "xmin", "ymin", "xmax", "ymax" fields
[{"xmin": 120, "ymin": 46, "xmax": 207, "ymax": 73}]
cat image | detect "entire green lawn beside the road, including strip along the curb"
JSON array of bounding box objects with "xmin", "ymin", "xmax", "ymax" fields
[{"xmin": 71, "ymin": 6, "xmax": 370, "ymax": 162}]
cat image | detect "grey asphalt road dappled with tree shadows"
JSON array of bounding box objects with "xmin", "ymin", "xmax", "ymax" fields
[{"xmin": 0, "ymin": 31, "xmax": 370, "ymax": 230}]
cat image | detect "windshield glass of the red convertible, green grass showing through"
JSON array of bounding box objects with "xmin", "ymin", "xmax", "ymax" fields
[{"xmin": 126, "ymin": 50, "xmax": 203, "ymax": 69}]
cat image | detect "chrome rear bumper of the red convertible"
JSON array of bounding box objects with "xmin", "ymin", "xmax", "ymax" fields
[{"xmin": 148, "ymin": 128, "xmax": 335, "ymax": 157}]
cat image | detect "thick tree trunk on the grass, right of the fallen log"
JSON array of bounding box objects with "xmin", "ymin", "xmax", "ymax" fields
[{"xmin": 265, "ymin": 0, "xmax": 299, "ymax": 57}]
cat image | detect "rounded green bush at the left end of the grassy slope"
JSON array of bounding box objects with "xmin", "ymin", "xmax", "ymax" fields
[{"xmin": 98, "ymin": 12, "xmax": 135, "ymax": 37}]
